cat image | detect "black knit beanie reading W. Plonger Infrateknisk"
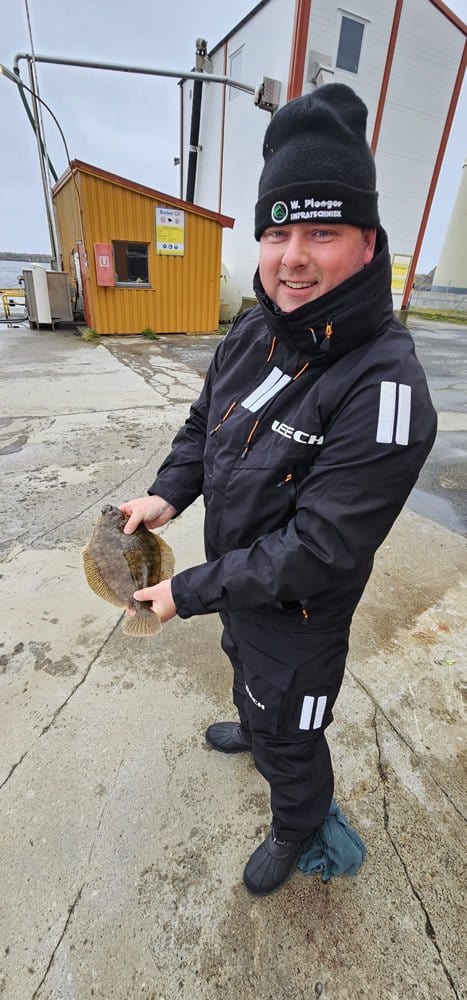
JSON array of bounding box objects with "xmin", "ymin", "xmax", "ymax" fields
[{"xmin": 255, "ymin": 83, "xmax": 379, "ymax": 240}]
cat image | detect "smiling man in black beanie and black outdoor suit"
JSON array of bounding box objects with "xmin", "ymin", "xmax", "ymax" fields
[{"xmin": 121, "ymin": 84, "xmax": 436, "ymax": 896}]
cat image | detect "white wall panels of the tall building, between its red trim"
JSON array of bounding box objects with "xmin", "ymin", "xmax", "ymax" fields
[{"xmin": 188, "ymin": 0, "xmax": 464, "ymax": 307}]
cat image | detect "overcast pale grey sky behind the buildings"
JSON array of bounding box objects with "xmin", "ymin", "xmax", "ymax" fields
[{"xmin": 0, "ymin": 0, "xmax": 467, "ymax": 270}]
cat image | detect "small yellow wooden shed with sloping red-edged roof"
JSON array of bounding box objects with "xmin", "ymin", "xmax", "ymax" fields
[{"xmin": 52, "ymin": 160, "xmax": 234, "ymax": 334}]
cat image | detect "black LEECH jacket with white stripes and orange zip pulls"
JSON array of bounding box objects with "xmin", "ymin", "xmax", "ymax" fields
[{"xmin": 149, "ymin": 231, "xmax": 436, "ymax": 626}]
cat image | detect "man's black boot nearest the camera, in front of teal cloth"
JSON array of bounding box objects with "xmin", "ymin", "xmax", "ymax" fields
[{"xmin": 243, "ymin": 828, "xmax": 308, "ymax": 896}]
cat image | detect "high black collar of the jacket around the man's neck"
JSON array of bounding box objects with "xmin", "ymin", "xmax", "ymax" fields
[{"xmin": 253, "ymin": 228, "xmax": 393, "ymax": 362}]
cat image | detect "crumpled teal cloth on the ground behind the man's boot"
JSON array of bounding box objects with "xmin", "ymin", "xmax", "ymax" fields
[{"xmin": 297, "ymin": 799, "xmax": 366, "ymax": 882}]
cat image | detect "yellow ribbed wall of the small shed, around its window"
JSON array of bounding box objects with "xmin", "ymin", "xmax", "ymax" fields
[{"xmin": 76, "ymin": 173, "xmax": 222, "ymax": 334}]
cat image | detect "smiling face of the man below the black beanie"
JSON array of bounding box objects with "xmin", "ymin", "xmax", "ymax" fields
[{"xmin": 259, "ymin": 222, "xmax": 376, "ymax": 312}]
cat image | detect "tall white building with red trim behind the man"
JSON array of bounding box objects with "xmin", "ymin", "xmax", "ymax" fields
[{"xmin": 182, "ymin": 0, "xmax": 467, "ymax": 308}]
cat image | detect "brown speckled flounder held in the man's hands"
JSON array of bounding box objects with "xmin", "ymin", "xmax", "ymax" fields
[{"xmin": 82, "ymin": 504, "xmax": 174, "ymax": 636}]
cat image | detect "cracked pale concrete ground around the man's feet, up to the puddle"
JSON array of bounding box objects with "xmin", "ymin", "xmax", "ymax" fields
[{"xmin": 0, "ymin": 328, "xmax": 467, "ymax": 1000}]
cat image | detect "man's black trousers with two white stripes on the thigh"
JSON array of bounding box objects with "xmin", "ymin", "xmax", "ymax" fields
[{"xmin": 221, "ymin": 612, "xmax": 350, "ymax": 841}]
